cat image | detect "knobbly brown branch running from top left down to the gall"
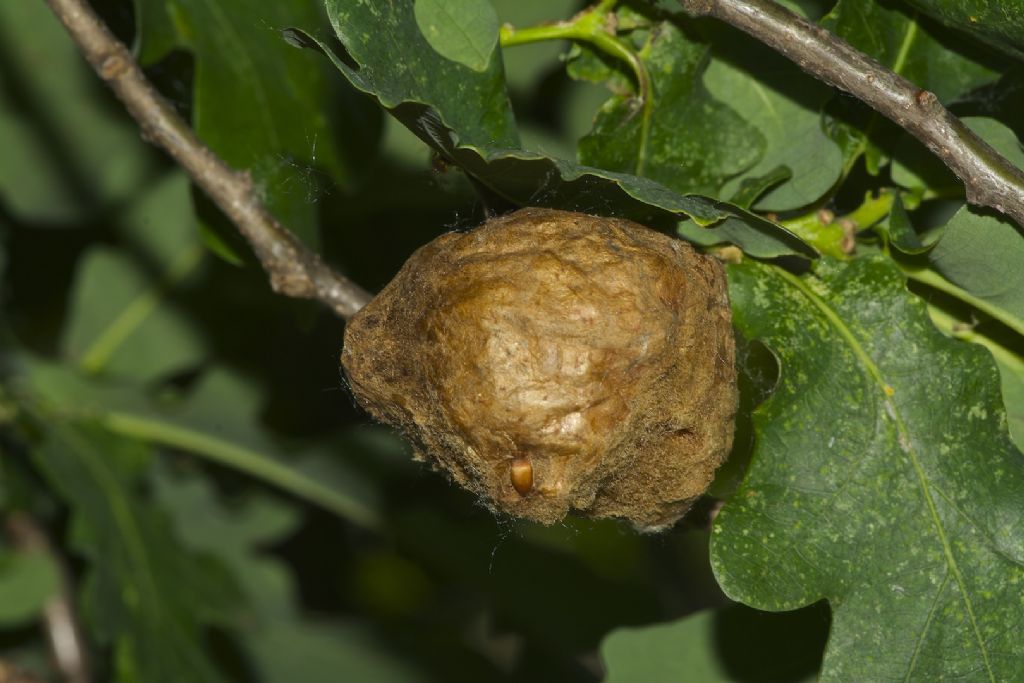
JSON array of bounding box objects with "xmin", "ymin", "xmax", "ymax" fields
[{"xmin": 46, "ymin": 0, "xmax": 372, "ymax": 319}]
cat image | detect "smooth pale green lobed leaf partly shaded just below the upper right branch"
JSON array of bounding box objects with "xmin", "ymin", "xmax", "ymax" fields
[{"xmin": 705, "ymin": 40, "xmax": 843, "ymax": 211}]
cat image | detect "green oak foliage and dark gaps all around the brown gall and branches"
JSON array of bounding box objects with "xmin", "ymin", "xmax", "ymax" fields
[{"xmin": 0, "ymin": 0, "xmax": 1024, "ymax": 683}]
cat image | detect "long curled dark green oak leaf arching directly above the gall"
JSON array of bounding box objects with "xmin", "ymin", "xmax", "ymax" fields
[{"xmin": 296, "ymin": 7, "xmax": 815, "ymax": 255}]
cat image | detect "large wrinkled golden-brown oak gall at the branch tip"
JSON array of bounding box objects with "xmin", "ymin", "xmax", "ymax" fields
[{"xmin": 342, "ymin": 209, "xmax": 736, "ymax": 530}]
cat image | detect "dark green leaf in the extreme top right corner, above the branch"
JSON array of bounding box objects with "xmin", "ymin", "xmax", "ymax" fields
[{"xmin": 906, "ymin": 0, "xmax": 1024, "ymax": 58}]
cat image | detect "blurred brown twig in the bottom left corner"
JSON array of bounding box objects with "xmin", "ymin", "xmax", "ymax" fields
[{"xmin": 6, "ymin": 512, "xmax": 90, "ymax": 683}]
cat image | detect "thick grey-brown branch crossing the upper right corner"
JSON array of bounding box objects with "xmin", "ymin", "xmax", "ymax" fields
[{"xmin": 679, "ymin": 0, "xmax": 1024, "ymax": 226}]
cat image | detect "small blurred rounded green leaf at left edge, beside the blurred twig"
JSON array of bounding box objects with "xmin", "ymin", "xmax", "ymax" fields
[{"xmin": 0, "ymin": 549, "xmax": 60, "ymax": 627}]
